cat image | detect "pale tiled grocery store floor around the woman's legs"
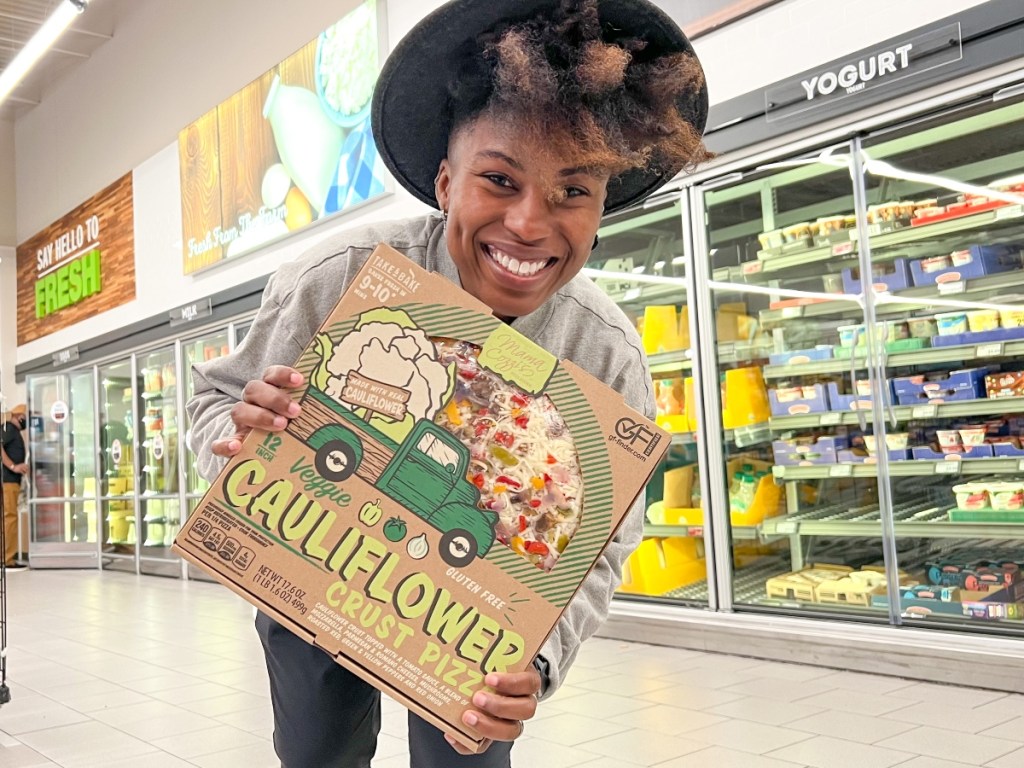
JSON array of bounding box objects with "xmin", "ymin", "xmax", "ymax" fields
[{"xmin": 0, "ymin": 570, "xmax": 1024, "ymax": 768}]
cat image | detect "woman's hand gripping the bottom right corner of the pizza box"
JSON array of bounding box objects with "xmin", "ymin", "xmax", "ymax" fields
[{"xmin": 444, "ymin": 667, "xmax": 541, "ymax": 755}]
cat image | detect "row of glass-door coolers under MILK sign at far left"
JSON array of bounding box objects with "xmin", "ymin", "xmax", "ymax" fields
[{"xmin": 28, "ymin": 318, "xmax": 249, "ymax": 578}]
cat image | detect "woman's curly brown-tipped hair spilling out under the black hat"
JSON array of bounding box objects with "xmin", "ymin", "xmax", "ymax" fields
[{"xmin": 449, "ymin": 0, "xmax": 714, "ymax": 185}]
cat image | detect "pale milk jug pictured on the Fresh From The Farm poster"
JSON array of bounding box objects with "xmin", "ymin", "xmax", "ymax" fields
[{"xmin": 263, "ymin": 76, "xmax": 342, "ymax": 215}]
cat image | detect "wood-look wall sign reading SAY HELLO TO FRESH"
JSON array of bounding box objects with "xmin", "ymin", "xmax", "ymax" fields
[{"xmin": 16, "ymin": 173, "xmax": 135, "ymax": 345}]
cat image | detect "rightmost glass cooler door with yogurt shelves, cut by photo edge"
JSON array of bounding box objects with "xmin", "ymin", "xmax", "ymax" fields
[{"xmin": 862, "ymin": 91, "xmax": 1024, "ymax": 633}]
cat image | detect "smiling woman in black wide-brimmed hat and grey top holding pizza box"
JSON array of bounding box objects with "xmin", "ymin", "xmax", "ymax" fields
[{"xmin": 188, "ymin": 0, "xmax": 709, "ymax": 768}]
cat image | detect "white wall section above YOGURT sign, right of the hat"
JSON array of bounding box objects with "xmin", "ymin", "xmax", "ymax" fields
[{"xmin": 696, "ymin": 0, "xmax": 985, "ymax": 103}]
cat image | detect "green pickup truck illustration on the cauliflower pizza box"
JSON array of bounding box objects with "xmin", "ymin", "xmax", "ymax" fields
[{"xmin": 288, "ymin": 315, "xmax": 498, "ymax": 567}]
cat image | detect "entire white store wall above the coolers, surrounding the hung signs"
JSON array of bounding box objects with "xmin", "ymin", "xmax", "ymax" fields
[{"xmin": 12, "ymin": 0, "xmax": 995, "ymax": 362}]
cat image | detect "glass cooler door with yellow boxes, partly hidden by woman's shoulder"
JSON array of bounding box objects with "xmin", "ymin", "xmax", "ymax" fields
[{"xmin": 586, "ymin": 195, "xmax": 709, "ymax": 605}]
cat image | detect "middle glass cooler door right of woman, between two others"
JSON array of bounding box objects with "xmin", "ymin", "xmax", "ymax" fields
[{"xmin": 693, "ymin": 144, "xmax": 901, "ymax": 621}]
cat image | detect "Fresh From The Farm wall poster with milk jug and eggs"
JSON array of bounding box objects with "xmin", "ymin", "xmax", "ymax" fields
[{"xmin": 178, "ymin": 0, "xmax": 388, "ymax": 274}]
